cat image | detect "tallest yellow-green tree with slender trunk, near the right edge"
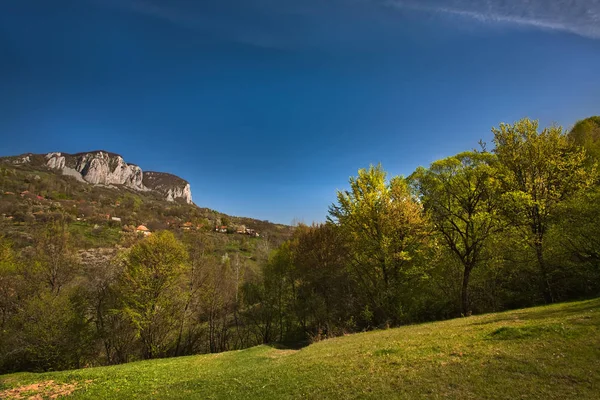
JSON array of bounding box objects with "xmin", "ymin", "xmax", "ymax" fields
[{"xmin": 492, "ymin": 118, "xmax": 595, "ymax": 303}]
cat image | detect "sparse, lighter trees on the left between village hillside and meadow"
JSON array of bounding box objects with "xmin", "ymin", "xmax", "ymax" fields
[{"xmin": 0, "ymin": 225, "xmax": 269, "ymax": 373}]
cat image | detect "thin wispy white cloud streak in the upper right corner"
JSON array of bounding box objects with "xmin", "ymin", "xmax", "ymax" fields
[{"xmin": 383, "ymin": 0, "xmax": 600, "ymax": 39}]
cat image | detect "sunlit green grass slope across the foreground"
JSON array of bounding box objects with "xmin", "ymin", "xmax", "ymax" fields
[{"xmin": 0, "ymin": 299, "xmax": 600, "ymax": 400}]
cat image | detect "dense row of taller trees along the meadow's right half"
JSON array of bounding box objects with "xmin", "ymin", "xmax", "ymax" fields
[{"xmin": 238, "ymin": 117, "xmax": 600, "ymax": 342}]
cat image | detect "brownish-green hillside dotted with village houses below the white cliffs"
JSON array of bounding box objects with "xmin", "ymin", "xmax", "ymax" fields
[{"xmin": 0, "ymin": 163, "xmax": 291, "ymax": 253}]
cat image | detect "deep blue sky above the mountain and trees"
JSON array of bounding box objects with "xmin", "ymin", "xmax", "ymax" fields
[{"xmin": 0, "ymin": 0, "xmax": 600, "ymax": 223}]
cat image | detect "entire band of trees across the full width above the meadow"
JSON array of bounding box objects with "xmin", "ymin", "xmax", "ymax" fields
[{"xmin": 0, "ymin": 117, "xmax": 600, "ymax": 374}]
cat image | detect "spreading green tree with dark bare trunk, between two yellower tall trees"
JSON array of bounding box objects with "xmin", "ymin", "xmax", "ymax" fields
[{"xmin": 411, "ymin": 152, "xmax": 502, "ymax": 316}]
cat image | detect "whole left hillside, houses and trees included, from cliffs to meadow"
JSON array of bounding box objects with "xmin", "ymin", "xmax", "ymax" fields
[{"xmin": 0, "ymin": 162, "xmax": 292, "ymax": 372}]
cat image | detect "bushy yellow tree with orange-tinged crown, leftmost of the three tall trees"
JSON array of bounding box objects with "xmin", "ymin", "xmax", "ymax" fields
[{"xmin": 328, "ymin": 165, "xmax": 429, "ymax": 325}]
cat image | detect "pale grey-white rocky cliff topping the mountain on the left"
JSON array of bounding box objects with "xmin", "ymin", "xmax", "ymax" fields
[{"xmin": 5, "ymin": 151, "xmax": 192, "ymax": 204}]
